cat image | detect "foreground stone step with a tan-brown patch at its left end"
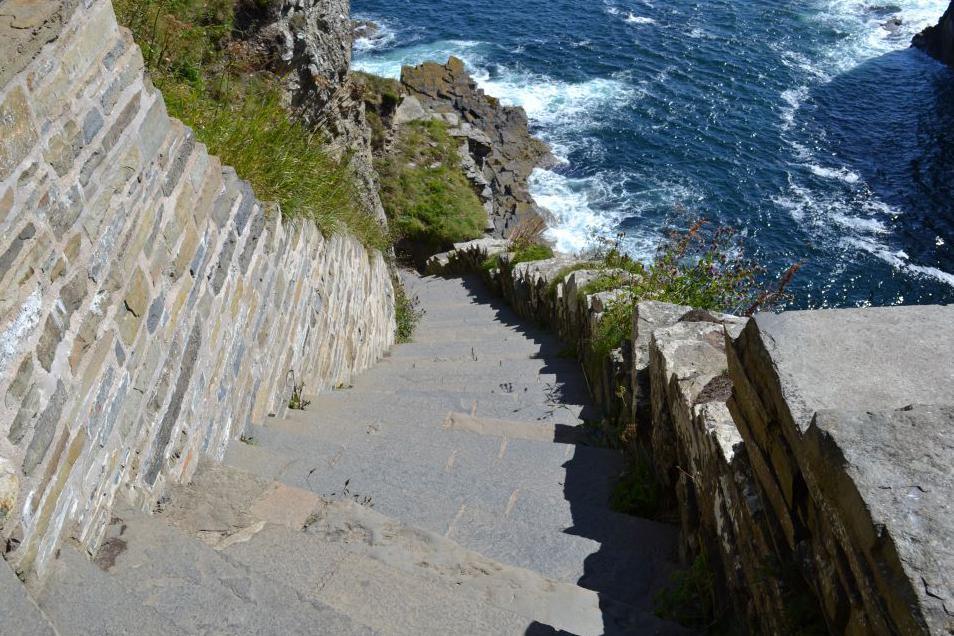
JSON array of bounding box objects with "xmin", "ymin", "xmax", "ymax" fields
[{"xmin": 154, "ymin": 465, "xmax": 604, "ymax": 634}]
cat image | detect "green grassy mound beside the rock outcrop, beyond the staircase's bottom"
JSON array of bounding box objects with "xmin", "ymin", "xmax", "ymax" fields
[{"xmin": 376, "ymin": 121, "xmax": 487, "ymax": 254}]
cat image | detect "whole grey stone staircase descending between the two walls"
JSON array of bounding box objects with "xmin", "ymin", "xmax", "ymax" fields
[{"xmin": 14, "ymin": 275, "xmax": 685, "ymax": 636}]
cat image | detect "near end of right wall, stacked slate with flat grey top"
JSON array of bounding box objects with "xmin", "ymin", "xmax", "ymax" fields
[{"xmin": 729, "ymin": 307, "xmax": 954, "ymax": 634}]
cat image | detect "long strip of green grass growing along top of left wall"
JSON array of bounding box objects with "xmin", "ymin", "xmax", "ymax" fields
[{"xmin": 115, "ymin": 0, "xmax": 389, "ymax": 249}]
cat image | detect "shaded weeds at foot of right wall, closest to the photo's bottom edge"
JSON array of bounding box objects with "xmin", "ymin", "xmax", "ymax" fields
[{"xmin": 653, "ymin": 553, "xmax": 718, "ymax": 630}]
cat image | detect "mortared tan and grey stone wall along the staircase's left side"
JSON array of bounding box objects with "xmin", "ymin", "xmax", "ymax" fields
[{"xmin": 0, "ymin": 0, "xmax": 395, "ymax": 574}]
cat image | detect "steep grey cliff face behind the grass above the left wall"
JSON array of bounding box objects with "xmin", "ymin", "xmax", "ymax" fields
[{"xmin": 236, "ymin": 0, "xmax": 385, "ymax": 222}]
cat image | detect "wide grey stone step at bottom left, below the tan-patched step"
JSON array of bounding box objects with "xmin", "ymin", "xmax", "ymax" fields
[{"xmin": 33, "ymin": 510, "xmax": 373, "ymax": 636}]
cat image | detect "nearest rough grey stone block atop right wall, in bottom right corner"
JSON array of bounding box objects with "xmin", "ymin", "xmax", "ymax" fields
[{"xmin": 801, "ymin": 408, "xmax": 954, "ymax": 634}]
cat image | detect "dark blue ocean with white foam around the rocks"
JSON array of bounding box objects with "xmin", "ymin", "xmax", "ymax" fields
[{"xmin": 352, "ymin": 0, "xmax": 954, "ymax": 307}]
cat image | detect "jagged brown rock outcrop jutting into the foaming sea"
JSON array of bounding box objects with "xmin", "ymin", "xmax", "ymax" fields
[{"xmin": 394, "ymin": 57, "xmax": 555, "ymax": 237}]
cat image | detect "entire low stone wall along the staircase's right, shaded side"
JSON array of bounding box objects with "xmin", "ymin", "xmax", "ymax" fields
[{"xmin": 429, "ymin": 239, "xmax": 954, "ymax": 635}]
